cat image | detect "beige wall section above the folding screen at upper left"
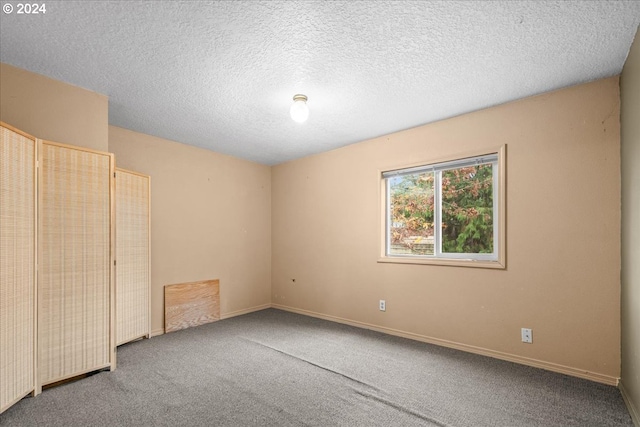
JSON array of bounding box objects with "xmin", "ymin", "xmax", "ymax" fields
[{"xmin": 0, "ymin": 63, "xmax": 109, "ymax": 151}]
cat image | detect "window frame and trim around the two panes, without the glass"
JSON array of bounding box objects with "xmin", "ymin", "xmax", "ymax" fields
[{"xmin": 378, "ymin": 145, "xmax": 506, "ymax": 269}]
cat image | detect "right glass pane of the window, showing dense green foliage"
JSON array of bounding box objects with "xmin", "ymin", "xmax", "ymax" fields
[{"xmin": 442, "ymin": 164, "xmax": 493, "ymax": 254}]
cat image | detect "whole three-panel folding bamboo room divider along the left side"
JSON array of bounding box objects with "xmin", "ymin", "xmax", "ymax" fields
[{"xmin": 0, "ymin": 122, "xmax": 150, "ymax": 413}]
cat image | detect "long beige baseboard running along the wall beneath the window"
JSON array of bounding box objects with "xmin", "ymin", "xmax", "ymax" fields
[{"xmin": 271, "ymin": 304, "xmax": 620, "ymax": 388}]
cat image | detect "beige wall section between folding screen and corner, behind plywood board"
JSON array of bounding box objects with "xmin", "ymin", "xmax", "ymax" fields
[{"xmin": 109, "ymin": 126, "xmax": 271, "ymax": 333}]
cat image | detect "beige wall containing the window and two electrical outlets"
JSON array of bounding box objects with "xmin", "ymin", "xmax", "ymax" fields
[{"xmin": 272, "ymin": 78, "xmax": 620, "ymax": 384}]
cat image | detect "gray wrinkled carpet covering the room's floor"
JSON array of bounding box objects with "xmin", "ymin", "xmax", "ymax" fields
[{"xmin": 0, "ymin": 309, "xmax": 633, "ymax": 427}]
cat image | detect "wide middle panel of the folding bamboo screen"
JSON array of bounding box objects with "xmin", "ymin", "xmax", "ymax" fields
[{"xmin": 38, "ymin": 142, "xmax": 115, "ymax": 384}]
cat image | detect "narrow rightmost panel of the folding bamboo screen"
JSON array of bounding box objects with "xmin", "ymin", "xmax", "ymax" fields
[{"xmin": 116, "ymin": 169, "xmax": 151, "ymax": 345}]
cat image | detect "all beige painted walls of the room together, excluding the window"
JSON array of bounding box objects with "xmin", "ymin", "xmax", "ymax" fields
[{"xmin": 0, "ymin": 61, "xmax": 628, "ymax": 392}]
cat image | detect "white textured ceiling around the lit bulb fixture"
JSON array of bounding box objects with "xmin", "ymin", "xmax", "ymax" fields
[{"xmin": 0, "ymin": 0, "xmax": 640, "ymax": 165}]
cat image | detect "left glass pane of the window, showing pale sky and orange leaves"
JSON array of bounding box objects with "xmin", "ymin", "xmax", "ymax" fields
[{"xmin": 388, "ymin": 172, "xmax": 434, "ymax": 255}]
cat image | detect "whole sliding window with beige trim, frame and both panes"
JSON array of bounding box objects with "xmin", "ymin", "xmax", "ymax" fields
[{"xmin": 380, "ymin": 148, "xmax": 504, "ymax": 268}]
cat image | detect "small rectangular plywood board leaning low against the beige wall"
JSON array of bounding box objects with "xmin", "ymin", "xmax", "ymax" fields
[{"xmin": 164, "ymin": 280, "xmax": 220, "ymax": 332}]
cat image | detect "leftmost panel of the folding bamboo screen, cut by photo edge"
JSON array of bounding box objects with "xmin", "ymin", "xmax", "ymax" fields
[{"xmin": 0, "ymin": 126, "xmax": 36, "ymax": 413}]
